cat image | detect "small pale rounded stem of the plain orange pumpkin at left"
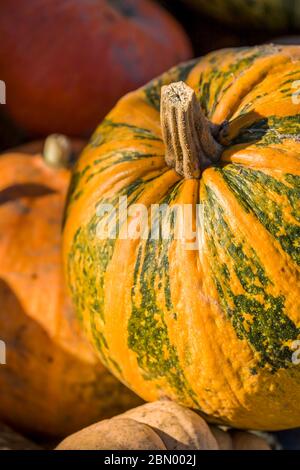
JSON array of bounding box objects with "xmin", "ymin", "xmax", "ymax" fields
[{"xmin": 43, "ymin": 134, "xmax": 72, "ymax": 168}]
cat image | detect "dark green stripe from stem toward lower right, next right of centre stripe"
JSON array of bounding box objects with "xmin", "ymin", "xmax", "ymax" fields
[{"xmin": 203, "ymin": 183, "xmax": 300, "ymax": 373}]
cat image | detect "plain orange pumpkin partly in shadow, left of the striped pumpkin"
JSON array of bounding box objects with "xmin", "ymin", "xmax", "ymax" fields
[{"xmin": 0, "ymin": 142, "xmax": 140, "ymax": 436}]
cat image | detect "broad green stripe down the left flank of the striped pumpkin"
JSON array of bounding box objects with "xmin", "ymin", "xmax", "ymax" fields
[{"xmin": 68, "ymin": 179, "xmax": 149, "ymax": 374}]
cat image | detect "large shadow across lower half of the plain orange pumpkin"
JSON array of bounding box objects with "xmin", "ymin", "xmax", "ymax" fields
[{"xmin": 0, "ymin": 279, "xmax": 141, "ymax": 437}]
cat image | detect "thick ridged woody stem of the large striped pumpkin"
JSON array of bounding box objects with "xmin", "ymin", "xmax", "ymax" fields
[{"xmin": 161, "ymin": 82, "xmax": 227, "ymax": 178}]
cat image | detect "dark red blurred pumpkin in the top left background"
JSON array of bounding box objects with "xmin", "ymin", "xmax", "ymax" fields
[{"xmin": 0, "ymin": 0, "xmax": 191, "ymax": 136}]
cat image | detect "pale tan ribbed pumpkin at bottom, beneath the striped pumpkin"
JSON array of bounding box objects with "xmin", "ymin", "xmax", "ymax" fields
[{"xmin": 56, "ymin": 400, "xmax": 270, "ymax": 451}]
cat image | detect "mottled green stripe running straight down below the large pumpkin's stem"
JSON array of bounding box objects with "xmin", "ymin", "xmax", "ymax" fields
[{"xmin": 128, "ymin": 183, "xmax": 199, "ymax": 408}]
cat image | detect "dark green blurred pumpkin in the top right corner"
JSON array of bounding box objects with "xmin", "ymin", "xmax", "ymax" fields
[{"xmin": 184, "ymin": 0, "xmax": 300, "ymax": 30}]
